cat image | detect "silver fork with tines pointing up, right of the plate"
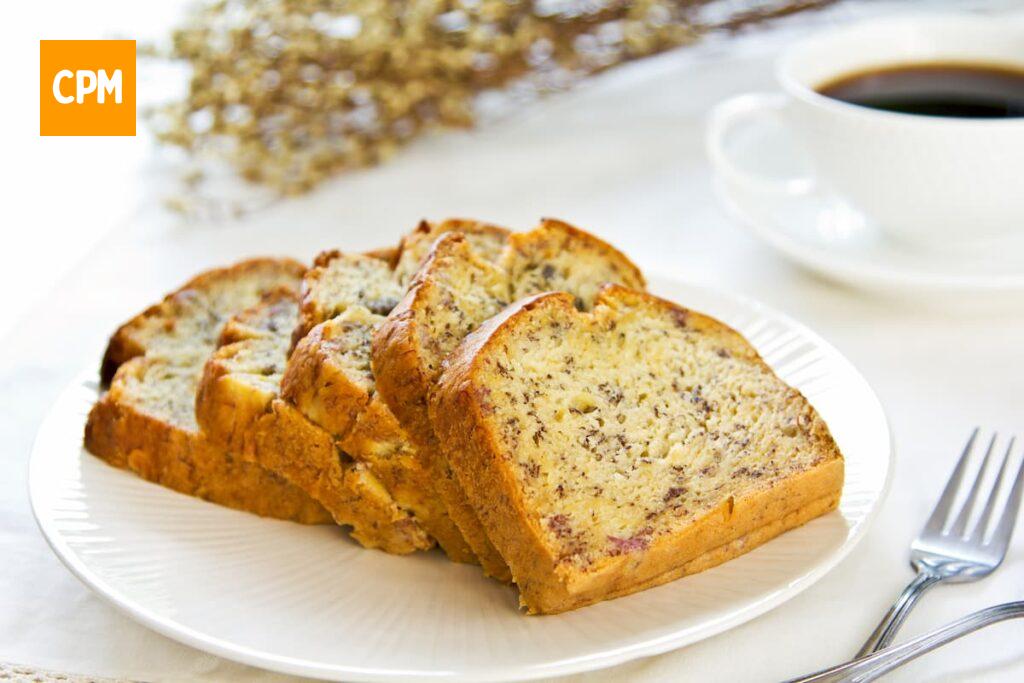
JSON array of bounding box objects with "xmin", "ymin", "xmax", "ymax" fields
[{"xmin": 855, "ymin": 428, "xmax": 1024, "ymax": 658}]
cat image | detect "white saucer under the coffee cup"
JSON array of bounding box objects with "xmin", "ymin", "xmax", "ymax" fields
[{"xmin": 716, "ymin": 131, "xmax": 1024, "ymax": 293}]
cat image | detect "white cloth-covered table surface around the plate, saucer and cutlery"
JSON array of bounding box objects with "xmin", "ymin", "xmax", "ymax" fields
[{"xmin": 6, "ymin": 2, "xmax": 1024, "ymax": 682}]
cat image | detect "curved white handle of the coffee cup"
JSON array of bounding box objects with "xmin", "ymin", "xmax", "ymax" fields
[{"xmin": 707, "ymin": 92, "xmax": 814, "ymax": 197}]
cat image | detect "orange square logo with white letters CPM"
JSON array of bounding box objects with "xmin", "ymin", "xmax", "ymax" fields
[{"xmin": 39, "ymin": 40, "xmax": 135, "ymax": 135}]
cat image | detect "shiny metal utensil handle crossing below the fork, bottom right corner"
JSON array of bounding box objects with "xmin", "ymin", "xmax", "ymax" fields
[{"xmin": 787, "ymin": 601, "xmax": 1024, "ymax": 683}]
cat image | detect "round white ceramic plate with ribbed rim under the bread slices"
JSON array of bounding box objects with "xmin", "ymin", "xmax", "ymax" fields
[{"xmin": 30, "ymin": 281, "xmax": 892, "ymax": 680}]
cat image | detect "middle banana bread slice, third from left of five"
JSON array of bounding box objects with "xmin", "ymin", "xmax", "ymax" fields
[{"xmin": 279, "ymin": 219, "xmax": 509, "ymax": 562}]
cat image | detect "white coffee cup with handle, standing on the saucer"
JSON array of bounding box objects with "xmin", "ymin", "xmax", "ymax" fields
[{"xmin": 708, "ymin": 15, "xmax": 1024, "ymax": 245}]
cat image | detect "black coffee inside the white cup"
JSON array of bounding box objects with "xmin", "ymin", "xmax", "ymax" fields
[{"xmin": 817, "ymin": 63, "xmax": 1024, "ymax": 119}]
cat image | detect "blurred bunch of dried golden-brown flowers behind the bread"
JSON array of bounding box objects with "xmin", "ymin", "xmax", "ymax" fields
[{"xmin": 153, "ymin": 0, "xmax": 828, "ymax": 195}]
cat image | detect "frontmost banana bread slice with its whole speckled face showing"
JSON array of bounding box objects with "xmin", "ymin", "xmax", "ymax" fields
[{"xmin": 430, "ymin": 286, "xmax": 844, "ymax": 613}]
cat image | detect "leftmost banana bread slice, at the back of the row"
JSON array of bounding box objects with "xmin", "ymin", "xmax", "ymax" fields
[{"xmin": 85, "ymin": 259, "xmax": 331, "ymax": 523}]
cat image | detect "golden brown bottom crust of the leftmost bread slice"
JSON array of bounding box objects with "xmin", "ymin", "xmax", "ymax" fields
[{"xmin": 85, "ymin": 357, "xmax": 331, "ymax": 524}]
